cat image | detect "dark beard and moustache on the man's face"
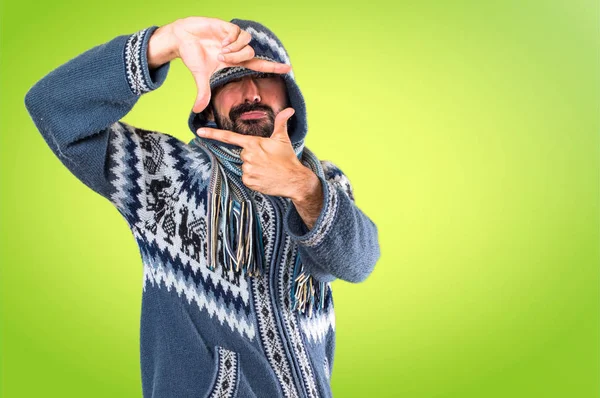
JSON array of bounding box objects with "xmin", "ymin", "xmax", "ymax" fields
[{"xmin": 213, "ymin": 104, "xmax": 275, "ymax": 138}]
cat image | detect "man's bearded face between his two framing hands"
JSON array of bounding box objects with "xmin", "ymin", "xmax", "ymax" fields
[{"xmin": 211, "ymin": 73, "xmax": 287, "ymax": 137}]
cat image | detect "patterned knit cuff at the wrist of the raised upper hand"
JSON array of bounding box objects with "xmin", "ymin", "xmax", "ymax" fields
[{"xmin": 124, "ymin": 25, "xmax": 171, "ymax": 96}]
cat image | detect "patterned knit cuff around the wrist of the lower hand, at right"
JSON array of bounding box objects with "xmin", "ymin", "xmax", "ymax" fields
[{"xmin": 283, "ymin": 176, "xmax": 339, "ymax": 247}]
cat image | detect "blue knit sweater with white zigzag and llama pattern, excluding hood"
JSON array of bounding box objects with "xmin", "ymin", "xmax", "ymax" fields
[{"xmin": 25, "ymin": 26, "xmax": 380, "ymax": 398}]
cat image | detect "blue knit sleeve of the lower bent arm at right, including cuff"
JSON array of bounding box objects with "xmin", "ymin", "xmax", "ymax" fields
[{"xmin": 284, "ymin": 160, "xmax": 380, "ymax": 283}]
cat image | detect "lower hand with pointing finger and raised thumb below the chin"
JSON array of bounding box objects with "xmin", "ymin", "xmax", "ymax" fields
[{"xmin": 198, "ymin": 108, "xmax": 316, "ymax": 199}]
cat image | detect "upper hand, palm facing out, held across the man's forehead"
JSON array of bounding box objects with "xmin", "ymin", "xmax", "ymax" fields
[{"xmin": 148, "ymin": 17, "xmax": 292, "ymax": 112}]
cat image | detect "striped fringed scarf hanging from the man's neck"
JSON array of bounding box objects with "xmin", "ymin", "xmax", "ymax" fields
[{"xmin": 190, "ymin": 138, "xmax": 327, "ymax": 317}]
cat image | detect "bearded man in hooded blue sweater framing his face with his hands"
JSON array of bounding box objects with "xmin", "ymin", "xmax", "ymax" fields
[{"xmin": 25, "ymin": 17, "xmax": 380, "ymax": 398}]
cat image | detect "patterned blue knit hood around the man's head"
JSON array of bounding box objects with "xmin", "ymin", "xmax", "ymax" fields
[{"xmin": 188, "ymin": 19, "xmax": 307, "ymax": 149}]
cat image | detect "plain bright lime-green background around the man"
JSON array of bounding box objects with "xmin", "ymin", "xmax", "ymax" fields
[{"xmin": 0, "ymin": 0, "xmax": 600, "ymax": 398}]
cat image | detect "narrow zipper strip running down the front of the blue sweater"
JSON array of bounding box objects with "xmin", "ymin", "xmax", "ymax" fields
[{"xmin": 264, "ymin": 195, "xmax": 308, "ymax": 397}]
